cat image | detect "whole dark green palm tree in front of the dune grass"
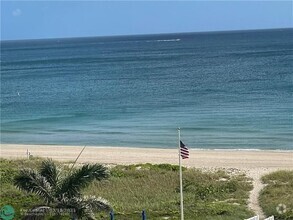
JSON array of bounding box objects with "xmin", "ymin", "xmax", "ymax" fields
[{"xmin": 14, "ymin": 159, "xmax": 110, "ymax": 219}]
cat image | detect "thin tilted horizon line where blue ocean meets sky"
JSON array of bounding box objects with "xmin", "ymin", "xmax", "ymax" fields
[{"xmin": 0, "ymin": 27, "xmax": 293, "ymax": 42}]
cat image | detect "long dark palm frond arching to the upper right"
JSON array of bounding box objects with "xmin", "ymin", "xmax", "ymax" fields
[{"xmin": 57, "ymin": 164, "xmax": 109, "ymax": 198}]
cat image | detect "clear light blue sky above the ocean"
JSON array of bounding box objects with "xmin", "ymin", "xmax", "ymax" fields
[{"xmin": 1, "ymin": 0, "xmax": 293, "ymax": 40}]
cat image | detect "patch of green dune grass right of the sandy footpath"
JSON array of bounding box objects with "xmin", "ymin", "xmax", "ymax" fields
[{"xmin": 259, "ymin": 170, "xmax": 293, "ymax": 220}]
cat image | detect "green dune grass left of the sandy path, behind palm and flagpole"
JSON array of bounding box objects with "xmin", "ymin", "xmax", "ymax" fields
[{"xmin": 0, "ymin": 158, "xmax": 253, "ymax": 220}]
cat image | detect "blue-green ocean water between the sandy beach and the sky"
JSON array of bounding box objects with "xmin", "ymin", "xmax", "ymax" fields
[{"xmin": 1, "ymin": 29, "xmax": 293, "ymax": 150}]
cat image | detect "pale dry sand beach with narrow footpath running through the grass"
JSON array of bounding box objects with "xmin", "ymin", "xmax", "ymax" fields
[{"xmin": 0, "ymin": 144, "xmax": 293, "ymax": 217}]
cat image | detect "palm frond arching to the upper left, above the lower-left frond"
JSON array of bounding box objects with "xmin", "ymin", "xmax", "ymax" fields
[{"xmin": 14, "ymin": 169, "xmax": 53, "ymax": 203}]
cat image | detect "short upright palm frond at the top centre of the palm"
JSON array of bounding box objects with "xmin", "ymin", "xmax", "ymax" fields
[{"xmin": 40, "ymin": 159, "xmax": 60, "ymax": 187}]
